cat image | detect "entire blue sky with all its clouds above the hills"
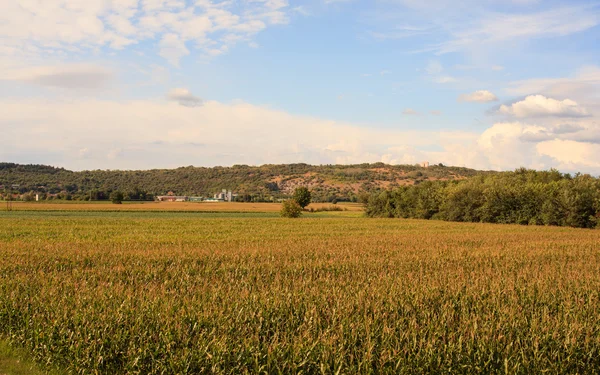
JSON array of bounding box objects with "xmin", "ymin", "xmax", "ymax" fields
[{"xmin": 0, "ymin": 0, "xmax": 600, "ymax": 175}]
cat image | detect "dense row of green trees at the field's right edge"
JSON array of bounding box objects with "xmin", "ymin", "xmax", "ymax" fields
[{"xmin": 366, "ymin": 169, "xmax": 600, "ymax": 228}]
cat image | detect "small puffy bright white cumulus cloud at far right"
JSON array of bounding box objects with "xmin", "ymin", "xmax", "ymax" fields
[{"xmin": 498, "ymin": 95, "xmax": 589, "ymax": 118}]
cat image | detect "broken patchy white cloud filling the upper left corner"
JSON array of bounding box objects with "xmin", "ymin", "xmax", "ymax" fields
[{"xmin": 0, "ymin": 0, "xmax": 290, "ymax": 65}]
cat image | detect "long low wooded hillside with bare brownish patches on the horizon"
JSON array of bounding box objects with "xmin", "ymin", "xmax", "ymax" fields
[{"xmin": 0, "ymin": 163, "xmax": 489, "ymax": 201}]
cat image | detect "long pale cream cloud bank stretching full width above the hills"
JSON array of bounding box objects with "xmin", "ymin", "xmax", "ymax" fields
[{"xmin": 0, "ymin": 96, "xmax": 600, "ymax": 173}]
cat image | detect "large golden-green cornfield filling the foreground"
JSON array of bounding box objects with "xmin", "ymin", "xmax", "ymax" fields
[{"xmin": 0, "ymin": 210, "xmax": 600, "ymax": 374}]
